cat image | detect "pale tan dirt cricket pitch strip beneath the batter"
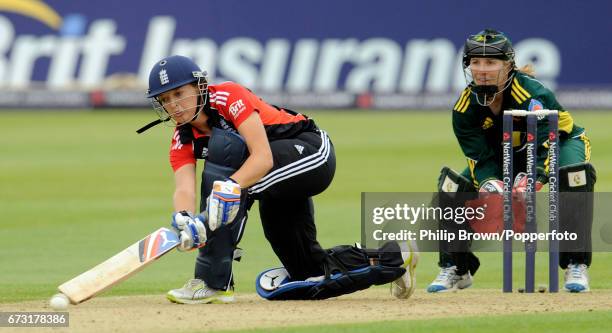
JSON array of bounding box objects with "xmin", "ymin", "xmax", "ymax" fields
[{"xmin": 0, "ymin": 288, "xmax": 612, "ymax": 333}]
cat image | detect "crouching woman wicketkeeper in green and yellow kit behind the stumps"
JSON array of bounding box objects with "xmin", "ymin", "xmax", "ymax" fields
[{"xmin": 427, "ymin": 29, "xmax": 596, "ymax": 292}]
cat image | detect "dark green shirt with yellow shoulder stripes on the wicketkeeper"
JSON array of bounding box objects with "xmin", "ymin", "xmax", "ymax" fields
[{"xmin": 453, "ymin": 71, "xmax": 584, "ymax": 188}]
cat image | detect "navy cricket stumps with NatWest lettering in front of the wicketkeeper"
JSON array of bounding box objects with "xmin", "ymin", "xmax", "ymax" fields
[{"xmin": 502, "ymin": 110, "xmax": 559, "ymax": 293}]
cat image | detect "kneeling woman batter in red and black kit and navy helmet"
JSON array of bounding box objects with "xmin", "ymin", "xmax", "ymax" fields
[{"xmin": 139, "ymin": 56, "xmax": 418, "ymax": 304}]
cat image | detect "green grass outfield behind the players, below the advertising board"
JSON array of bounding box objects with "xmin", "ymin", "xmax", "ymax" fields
[{"xmin": 0, "ymin": 111, "xmax": 612, "ymax": 316}]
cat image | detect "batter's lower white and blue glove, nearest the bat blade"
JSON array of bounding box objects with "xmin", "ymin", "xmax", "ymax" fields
[{"xmin": 172, "ymin": 210, "xmax": 207, "ymax": 251}]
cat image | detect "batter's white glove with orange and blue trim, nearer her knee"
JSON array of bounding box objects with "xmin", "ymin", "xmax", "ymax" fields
[{"xmin": 206, "ymin": 179, "xmax": 241, "ymax": 231}]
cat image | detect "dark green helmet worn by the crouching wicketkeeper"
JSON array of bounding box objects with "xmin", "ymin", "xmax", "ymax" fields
[{"xmin": 463, "ymin": 29, "xmax": 514, "ymax": 67}]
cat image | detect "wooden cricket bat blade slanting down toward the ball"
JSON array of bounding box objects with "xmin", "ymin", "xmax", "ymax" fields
[{"xmin": 58, "ymin": 228, "xmax": 179, "ymax": 304}]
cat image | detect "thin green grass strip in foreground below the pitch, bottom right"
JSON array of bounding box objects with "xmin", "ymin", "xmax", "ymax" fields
[{"xmin": 220, "ymin": 311, "xmax": 612, "ymax": 333}]
